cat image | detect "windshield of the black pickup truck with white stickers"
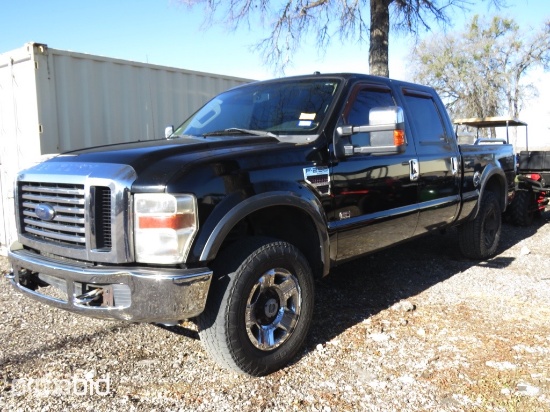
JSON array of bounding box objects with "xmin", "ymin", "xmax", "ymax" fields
[{"xmin": 172, "ymin": 79, "xmax": 339, "ymax": 140}]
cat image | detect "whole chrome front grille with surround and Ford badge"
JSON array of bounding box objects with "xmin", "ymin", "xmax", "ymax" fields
[{"xmin": 16, "ymin": 158, "xmax": 137, "ymax": 263}]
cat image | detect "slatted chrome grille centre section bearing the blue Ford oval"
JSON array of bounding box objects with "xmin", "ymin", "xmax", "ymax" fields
[{"xmin": 20, "ymin": 182, "xmax": 86, "ymax": 248}]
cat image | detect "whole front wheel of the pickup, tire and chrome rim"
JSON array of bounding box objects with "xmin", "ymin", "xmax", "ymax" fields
[{"xmin": 198, "ymin": 238, "xmax": 314, "ymax": 376}]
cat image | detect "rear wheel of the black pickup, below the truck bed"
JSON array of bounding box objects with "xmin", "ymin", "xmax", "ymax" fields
[{"xmin": 458, "ymin": 192, "xmax": 502, "ymax": 259}]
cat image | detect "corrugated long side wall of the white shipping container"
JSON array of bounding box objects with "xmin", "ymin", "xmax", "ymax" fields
[{"xmin": 37, "ymin": 44, "xmax": 250, "ymax": 153}]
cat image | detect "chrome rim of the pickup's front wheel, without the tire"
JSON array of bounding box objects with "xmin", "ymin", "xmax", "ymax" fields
[{"xmin": 245, "ymin": 268, "xmax": 302, "ymax": 351}]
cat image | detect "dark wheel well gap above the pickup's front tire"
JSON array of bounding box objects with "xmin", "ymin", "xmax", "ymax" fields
[{"xmin": 220, "ymin": 206, "xmax": 323, "ymax": 277}]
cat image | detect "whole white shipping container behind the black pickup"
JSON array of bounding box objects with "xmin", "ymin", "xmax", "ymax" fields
[{"xmin": 0, "ymin": 43, "xmax": 251, "ymax": 255}]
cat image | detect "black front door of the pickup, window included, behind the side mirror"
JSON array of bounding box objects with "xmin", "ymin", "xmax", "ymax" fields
[{"xmin": 327, "ymin": 83, "xmax": 418, "ymax": 260}]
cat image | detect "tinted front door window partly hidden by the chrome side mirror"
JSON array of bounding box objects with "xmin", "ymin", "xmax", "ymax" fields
[{"xmin": 345, "ymin": 88, "xmax": 395, "ymax": 146}]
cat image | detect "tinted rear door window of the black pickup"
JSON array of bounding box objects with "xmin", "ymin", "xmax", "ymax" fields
[{"xmin": 405, "ymin": 94, "xmax": 445, "ymax": 143}]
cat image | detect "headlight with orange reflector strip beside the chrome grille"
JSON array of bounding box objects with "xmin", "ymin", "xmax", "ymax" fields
[{"xmin": 134, "ymin": 193, "xmax": 199, "ymax": 264}]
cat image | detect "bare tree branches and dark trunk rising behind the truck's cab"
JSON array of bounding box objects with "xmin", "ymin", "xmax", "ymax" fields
[{"xmin": 179, "ymin": 0, "xmax": 516, "ymax": 76}]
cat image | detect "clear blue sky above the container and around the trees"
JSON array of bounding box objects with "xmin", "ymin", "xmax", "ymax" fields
[{"xmin": 0, "ymin": 0, "xmax": 550, "ymax": 146}]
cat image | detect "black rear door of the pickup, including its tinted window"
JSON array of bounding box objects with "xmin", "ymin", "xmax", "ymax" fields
[{"xmin": 403, "ymin": 88, "xmax": 460, "ymax": 235}]
